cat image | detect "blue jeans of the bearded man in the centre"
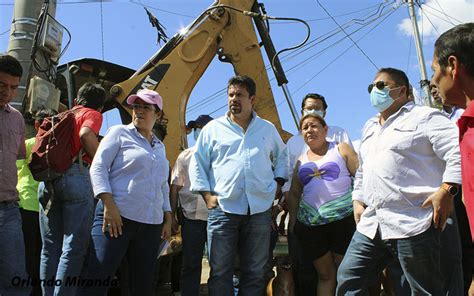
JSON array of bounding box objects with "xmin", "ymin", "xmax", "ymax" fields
[{"xmin": 207, "ymin": 206, "xmax": 271, "ymax": 296}]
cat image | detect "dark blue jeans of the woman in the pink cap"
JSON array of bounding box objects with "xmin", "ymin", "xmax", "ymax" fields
[{"xmin": 77, "ymin": 201, "xmax": 162, "ymax": 296}]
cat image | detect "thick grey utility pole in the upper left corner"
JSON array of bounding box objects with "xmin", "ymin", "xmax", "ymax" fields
[{"xmin": 7, "ymin": 0, "xmax": 56, "ymax": 112}]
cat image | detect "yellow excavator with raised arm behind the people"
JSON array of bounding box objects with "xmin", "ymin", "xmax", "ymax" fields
[{"xmin": 57, "ymin": 0, "xmax": 304, "ymax": 165}]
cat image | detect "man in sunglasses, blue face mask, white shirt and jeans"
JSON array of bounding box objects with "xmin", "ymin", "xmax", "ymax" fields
[{"xmin": 337, "ymin": 68, "xmax": 461, "ymax": 295}]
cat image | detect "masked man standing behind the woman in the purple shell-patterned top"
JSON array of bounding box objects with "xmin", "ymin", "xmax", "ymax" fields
[{"xmin": 282, "ymin": 93, "xmax": 352, "ymax": 295}]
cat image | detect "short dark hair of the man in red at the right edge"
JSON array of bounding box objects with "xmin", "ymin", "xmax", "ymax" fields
[{"xmin": 434, "ymin": 23, "xmax": 474, "ymax": 76}]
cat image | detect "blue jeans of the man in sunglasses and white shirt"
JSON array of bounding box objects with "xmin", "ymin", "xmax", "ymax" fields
[{"xmin": 336, "ymin": 226, "xmax": 443, "ymax": 295}]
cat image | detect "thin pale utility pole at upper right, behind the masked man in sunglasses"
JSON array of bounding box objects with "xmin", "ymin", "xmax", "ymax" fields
[{"xmin": 406, "ymin": 0, "xmax": 432, "ymax": 107}]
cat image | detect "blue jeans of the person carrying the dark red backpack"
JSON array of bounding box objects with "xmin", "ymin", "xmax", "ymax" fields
[{"xmin": 39, "ymin": 164, "xmax": 94, "ymax": 296}]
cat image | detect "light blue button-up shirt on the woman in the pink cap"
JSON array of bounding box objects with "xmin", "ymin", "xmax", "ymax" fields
[{"xmin": 90, "ymin": 124, "xmax": 171, "ymax": 224}]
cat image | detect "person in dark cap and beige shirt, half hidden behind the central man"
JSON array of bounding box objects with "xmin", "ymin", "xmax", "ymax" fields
[{"xmin": 170, "ymin": 115, "xmax": 213, "ymax": 296}]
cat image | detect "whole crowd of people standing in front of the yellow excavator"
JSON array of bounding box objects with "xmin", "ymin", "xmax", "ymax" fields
[{"xmin": 0, "ymin": 23, "xmax": 474, "ymax": 296}]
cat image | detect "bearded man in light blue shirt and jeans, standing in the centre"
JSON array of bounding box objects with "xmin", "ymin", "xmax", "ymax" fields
[{"xmin": 189, "ymin": 76, "xmax": 289, "ymax": 296}]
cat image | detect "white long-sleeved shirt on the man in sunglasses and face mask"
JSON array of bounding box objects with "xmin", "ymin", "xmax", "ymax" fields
[{"xmin": 352, "ymin": 102, "xmax": 461, "ymax": 239}]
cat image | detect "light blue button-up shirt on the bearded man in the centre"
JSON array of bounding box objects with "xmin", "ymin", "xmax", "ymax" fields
[{"xmin": 189, "ymin": 113, "xmax": 289, "ymax": 215}]
